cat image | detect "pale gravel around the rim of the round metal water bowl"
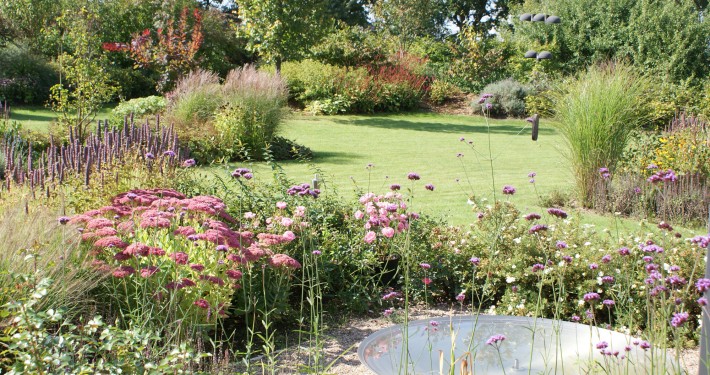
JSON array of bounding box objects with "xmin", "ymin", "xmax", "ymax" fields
[{"xmin": 249, "ymin": 307, "xmax": 699, "ymax": 375}]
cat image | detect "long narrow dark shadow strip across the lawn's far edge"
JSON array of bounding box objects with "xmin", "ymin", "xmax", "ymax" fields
[{"xmin": 334, "ymin": 117, "xmax": 554, "ymax": 135}]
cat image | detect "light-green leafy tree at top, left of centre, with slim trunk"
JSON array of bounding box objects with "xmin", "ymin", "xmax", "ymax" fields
[{"xmin": 237, "ymin": 0, "xmax": 326, "ymax": 73}]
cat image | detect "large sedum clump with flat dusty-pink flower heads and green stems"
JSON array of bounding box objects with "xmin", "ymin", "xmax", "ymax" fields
[{"xmin": 60, "ymin": 189, "xmax": 301, "ymax": 326}]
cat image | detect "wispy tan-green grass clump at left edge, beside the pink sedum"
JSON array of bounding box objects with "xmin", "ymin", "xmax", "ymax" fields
[{"xmin": 0, "ymin": 204, "xmax": 100, "ymax": 318}]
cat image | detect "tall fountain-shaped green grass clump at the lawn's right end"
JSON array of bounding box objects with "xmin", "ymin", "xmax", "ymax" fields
[{"xmin": 555, "ymin": 62, "xmax": 648, "ymax": 207}]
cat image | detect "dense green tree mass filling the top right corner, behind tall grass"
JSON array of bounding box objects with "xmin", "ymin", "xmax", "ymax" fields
[{"xmin": 515, "ymin": 0, "xmax": 710, "ymax": 81}]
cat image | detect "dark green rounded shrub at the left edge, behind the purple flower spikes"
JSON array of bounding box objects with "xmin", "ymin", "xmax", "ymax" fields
[{"xmin": 0, "ymin": 44, "xmax": 59, "ymax": 104}]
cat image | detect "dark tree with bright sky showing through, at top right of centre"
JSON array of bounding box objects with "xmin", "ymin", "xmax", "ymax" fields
[{"xmin": 445, "ymin": 0, "xmax": 515, "ymax": 35}]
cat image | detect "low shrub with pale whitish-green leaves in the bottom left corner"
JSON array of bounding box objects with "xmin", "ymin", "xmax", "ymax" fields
[{"xmin": 0, "ymin": 276, "xmax": 207, "ymax": 374}]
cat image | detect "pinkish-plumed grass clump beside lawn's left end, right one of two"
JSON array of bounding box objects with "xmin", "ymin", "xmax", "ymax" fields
[{"xmin": 214, "ymin": 66, "xmax": 287, "ymax": 159}]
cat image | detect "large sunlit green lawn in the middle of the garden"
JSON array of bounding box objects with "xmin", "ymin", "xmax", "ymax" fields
[{"xmin": 212, "ymin": 114, "xmax": 610, "ymax": 225}]
